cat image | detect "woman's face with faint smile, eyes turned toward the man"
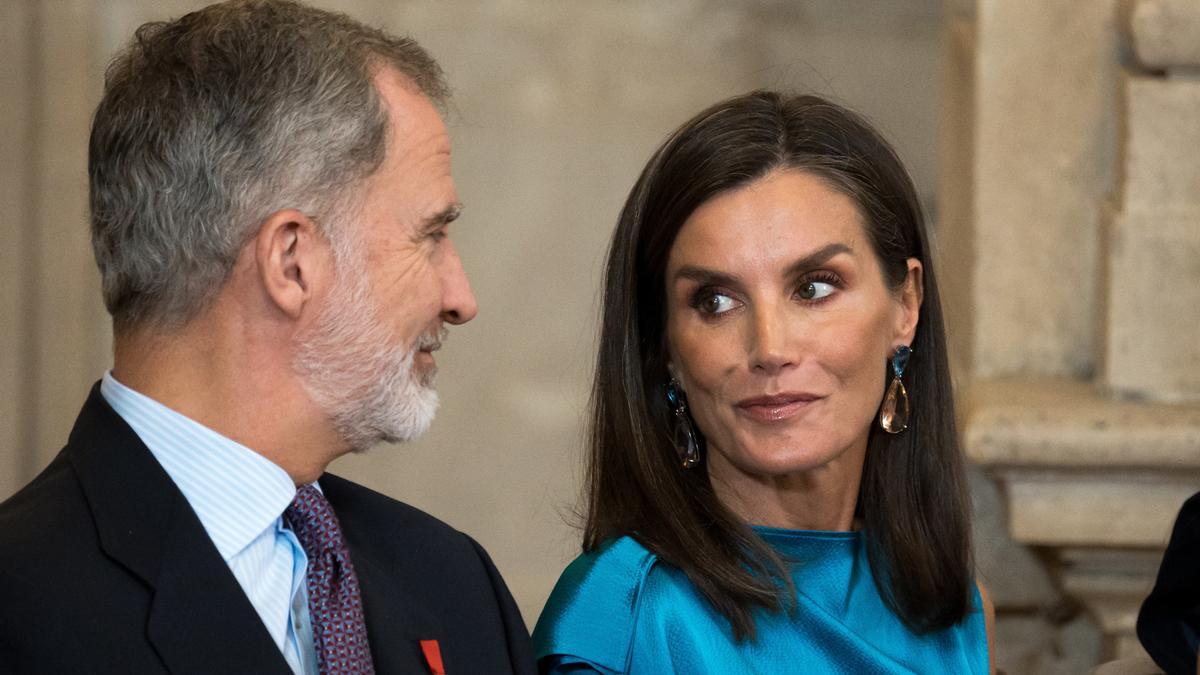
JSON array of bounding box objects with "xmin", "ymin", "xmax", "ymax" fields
[{"xmin": 666, "ymin": 171, "xmax": 922, "ymax": 490}]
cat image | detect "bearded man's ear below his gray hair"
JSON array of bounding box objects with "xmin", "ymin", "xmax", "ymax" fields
[{"xmin": 254, "ymin": 209, "xmax": 331, "ymax": 319}]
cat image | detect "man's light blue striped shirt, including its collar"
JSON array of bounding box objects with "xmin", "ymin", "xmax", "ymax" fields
[{"xmin": 100, "ymin": 371, "xmax": 317, "ymax": 675}]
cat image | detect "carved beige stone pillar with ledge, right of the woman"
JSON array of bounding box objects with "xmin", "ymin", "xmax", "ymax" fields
[{"xmin": 943, "ymin": 0, "xmax": 1200, "ymax": 673}]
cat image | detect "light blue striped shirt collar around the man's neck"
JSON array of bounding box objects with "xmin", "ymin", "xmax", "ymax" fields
[{"xmin": 100, "ymin": 371, "xmax": 296, "ymax": 562}]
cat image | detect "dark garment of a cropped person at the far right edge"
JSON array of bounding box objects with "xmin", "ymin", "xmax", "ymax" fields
[{"xmin": 1138, "ymin": 494, "xmax": 1200, "ymax": 675}]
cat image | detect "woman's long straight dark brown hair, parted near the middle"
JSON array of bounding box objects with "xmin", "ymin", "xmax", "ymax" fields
[{"xmin": 583, "ymin": 91, "xmax": 973, "ymax": 639}]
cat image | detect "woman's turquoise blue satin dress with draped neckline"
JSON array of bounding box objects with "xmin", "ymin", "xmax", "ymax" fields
[{"xmin": 533, "ymin": 527, "xmax": 988, "ymax": 675}]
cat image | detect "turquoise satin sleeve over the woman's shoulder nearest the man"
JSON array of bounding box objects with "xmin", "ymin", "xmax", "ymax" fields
[{"xmin": 533, "ymin": 537, "xmax": 686, "ymax": 673}]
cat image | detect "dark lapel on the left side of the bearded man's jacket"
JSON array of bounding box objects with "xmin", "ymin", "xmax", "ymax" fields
[{"xmin": 65, "ymin": 386, "xmax": 290, "ymax": 673}]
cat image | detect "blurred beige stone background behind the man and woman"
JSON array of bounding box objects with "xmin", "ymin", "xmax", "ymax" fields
[{"xmin": 0, "ymin": 0, "xmax": 1200, "ymax": 674}]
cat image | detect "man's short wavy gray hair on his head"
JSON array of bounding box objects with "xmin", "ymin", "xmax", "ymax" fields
[{"xmin": 88, "ymin": 0, "xmax": 448, "ymax": 334}]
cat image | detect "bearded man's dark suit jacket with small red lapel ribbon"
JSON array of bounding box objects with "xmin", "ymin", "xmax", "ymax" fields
[{"xmin": 0, "ymin": 386, "xmax": 534, "ymax": 675}]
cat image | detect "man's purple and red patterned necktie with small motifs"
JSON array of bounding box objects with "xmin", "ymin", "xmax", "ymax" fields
[{"xmin": 283, "ymin": 485, "xmax": 374, "ymax": 675}]
